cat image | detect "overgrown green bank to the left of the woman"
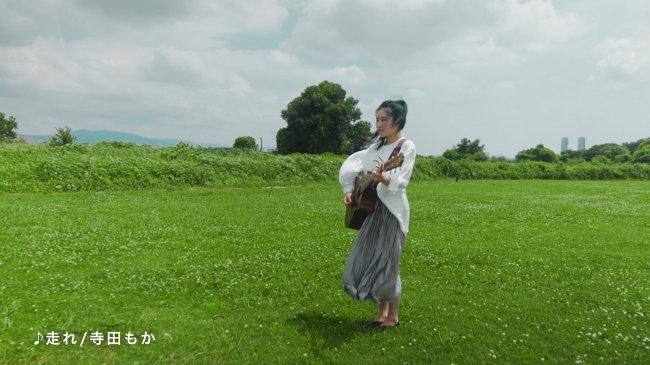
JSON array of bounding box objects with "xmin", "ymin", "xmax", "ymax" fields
[{"xmin": 0, "ymin": 142, "xmax": 346, "ymax": 192}]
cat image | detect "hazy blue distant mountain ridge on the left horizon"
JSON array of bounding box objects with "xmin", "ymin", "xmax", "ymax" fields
[{"xmin": 18, "ymin": 129, "xmax": 232, "ymax": 147}]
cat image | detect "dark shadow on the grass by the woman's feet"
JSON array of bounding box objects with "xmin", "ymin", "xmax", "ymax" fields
[{"xmin": 286, "ymin": 312, "xmax": 378, "ymax": 358}]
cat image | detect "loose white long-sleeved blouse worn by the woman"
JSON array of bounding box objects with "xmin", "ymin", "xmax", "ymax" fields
[{"xmin": 339, "ymin": 136, "xmax": 415, "ymax": 235}]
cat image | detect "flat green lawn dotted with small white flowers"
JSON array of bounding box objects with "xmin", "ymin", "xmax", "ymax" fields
[{"xmin": 0, "ymin": 181, "xmax": 650, "ymax": 365}]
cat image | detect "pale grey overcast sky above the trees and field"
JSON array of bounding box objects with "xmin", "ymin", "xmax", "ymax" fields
[{"xmin": 0, "ymin": 0, "xmax": 650, "ymax": 157}]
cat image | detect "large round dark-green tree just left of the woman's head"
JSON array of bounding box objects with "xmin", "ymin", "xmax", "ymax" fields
[{"xmin": 276, "ymin": 81, "xmax": 365, "ymax": 155}]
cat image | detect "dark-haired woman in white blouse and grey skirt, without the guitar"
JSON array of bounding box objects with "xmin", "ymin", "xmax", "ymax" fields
[{"xmin": 339, "ymin": 100, "xmax": 415, "ymax": 327}]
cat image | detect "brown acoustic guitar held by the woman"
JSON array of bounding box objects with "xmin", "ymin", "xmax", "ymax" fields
[{"xmin": 345, "ymin": 152, "xmax": 404, "ymax": 230}]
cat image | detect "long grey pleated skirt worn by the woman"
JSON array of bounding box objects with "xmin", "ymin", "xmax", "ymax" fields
[{"xmin": 343, "ymin": 198, "xmax": 406, "ymax": 304}]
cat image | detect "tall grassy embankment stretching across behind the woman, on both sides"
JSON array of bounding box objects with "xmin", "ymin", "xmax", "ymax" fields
[{"xmin": 0, "ymin": 142, "xmax": 650, "ymax": 193}]
